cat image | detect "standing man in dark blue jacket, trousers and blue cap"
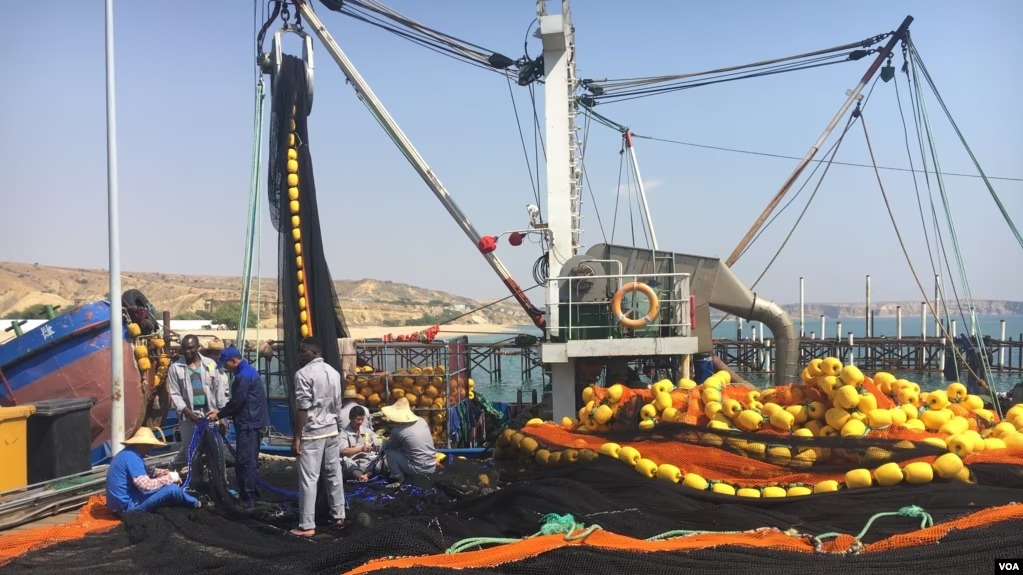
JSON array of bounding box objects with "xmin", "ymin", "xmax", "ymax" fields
[{"xmin": 208, "ymin": 346, "xmax": 270, "ymax": 507}]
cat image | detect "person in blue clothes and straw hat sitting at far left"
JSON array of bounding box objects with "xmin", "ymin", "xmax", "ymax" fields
[{"xmin": 106, "ymin": 428, "xmax": 199, "ymax": 514}]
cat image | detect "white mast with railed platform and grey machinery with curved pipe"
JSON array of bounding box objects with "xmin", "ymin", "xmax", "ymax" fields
[{"xmin": 537, "ymin": 0, "xmax": 799, "ymax": 417}]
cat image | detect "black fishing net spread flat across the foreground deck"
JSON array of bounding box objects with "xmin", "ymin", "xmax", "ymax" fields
[{"xmin": 3, "ymin": 427, "xmax": 1023, "ymax": 575}]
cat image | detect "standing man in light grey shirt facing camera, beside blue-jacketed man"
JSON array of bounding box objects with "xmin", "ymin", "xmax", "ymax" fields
[{"xmin": 167, "ymin": 335, "xmax": 227, "ymax": 482}]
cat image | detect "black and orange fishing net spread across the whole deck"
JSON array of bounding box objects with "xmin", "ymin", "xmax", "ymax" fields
[{"xmin": 6, "ymin": 362, "xmax": 1023, "ymax": 575}]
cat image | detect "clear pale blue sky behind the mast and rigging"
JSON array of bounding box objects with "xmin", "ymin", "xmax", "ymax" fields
[{"xmin": 0, "ymin": 0, "xmax": 1023, "ymax": 303}]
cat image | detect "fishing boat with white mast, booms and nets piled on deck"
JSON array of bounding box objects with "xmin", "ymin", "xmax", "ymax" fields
[{"xmin": 1, "ymin": 0, "xmax": 1023, "ymax": 574}]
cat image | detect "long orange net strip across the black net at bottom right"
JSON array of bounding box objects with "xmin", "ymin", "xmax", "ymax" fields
[{"xmin": 345, "ymin": 504, "xmax": 1023, "ymax": 575}]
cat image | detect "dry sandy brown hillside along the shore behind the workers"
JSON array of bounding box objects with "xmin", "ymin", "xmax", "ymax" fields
[{"xmin": 0, "ymin": 262, "xmax": 530, "ymax": 325}]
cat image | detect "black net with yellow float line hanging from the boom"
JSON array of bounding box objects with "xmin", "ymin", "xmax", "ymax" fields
[{"xmin": 267, "ymin": 55, "xmax": 348, "ymax": 427}]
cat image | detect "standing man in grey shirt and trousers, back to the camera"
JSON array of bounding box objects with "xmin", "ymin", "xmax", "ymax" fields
[{"xmin": 292, "ymin": 338, "xmax": 345, "ymax": 537}]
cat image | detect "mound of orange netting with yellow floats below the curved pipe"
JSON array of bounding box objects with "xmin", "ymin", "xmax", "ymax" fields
[{"xmin": 515, "ymin": 357, "xmax": 1023, "ymax": 497}]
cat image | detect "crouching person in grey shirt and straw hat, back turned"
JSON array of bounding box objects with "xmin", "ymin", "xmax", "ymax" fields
[{"xmin": 381, "ymin": 397, "xmax": 437, "ymax": 487}]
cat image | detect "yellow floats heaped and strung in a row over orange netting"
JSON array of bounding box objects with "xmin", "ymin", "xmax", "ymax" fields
[{"xmin": 495, "ymin": 357, "xmax": 1023, "ymax": 497}]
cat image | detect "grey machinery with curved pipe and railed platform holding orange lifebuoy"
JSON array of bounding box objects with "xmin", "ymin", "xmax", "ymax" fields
[{"xmin": 542, "ymin": 244, "xmax": 799, "ymax": 417}]
